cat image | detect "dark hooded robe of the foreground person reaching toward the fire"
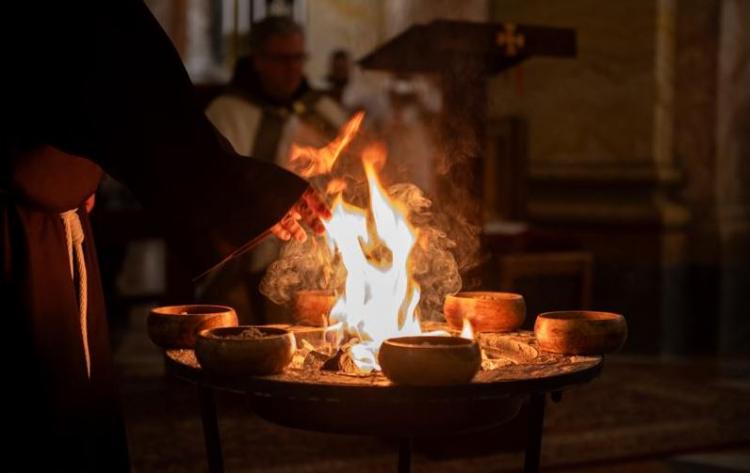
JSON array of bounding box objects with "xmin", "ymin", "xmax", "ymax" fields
[{"xmin": 0, "ymin": 0, "xmax": 307, "ymax": 472}]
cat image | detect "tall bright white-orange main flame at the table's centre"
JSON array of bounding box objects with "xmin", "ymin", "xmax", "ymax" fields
[{"xmin": 324, "ymin": 145, "xmax": 421, "ymax": 371}]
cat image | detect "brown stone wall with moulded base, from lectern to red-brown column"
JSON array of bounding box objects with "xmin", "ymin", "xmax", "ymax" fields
[{"xmin": 490, "ymin": 0, "xmax": 710, "ymax": 352}]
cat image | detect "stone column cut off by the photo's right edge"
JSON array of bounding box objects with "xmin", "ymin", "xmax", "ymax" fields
[{"xmin": 716, "ymin": 0, "xmax": 750, "ymax": 354}]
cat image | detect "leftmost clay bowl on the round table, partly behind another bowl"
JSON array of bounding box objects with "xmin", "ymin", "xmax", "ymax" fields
[{"xmin": 146, "ymin": 305, "xmax": 237, "ymax": 348}]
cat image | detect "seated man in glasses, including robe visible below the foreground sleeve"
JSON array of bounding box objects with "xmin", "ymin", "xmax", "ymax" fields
[{"xmin": 200, "ymin": 16, "xmax": 348, "ymax": 323}]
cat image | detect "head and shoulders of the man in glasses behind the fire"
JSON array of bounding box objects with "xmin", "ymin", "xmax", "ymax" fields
[{"xmin": 206, "ymin": 16, "xmax": 348, "ymax": 165}]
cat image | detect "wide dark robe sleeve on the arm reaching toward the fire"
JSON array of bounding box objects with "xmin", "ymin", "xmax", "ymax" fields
[{"xmin": 44, "ymin": 0, "xmax": 308, "ymax": 271}]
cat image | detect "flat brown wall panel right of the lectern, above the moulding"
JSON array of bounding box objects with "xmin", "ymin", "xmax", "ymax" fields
[{"xmin": 490, "ymin": 0, "xmax": 656, "ymax": 172}]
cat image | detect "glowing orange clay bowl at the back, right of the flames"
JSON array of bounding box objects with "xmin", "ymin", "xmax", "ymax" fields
[{"xmin": 443, "ymin": 292, "xmax": 526, "ymax": 332}]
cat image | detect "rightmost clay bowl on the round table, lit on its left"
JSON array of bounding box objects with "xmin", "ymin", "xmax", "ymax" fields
[{"xmin": 534, "ymin": 310, "xmax": 628, "ymax": 355}]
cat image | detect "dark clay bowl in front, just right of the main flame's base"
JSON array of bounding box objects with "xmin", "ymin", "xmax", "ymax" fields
[{"xmin": 378, "ymin": 336, "xmax": 482, "ymax": 386}]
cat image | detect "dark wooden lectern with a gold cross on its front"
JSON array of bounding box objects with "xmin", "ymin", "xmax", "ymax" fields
[{"xmin": 359, "ymin": 20, "xmax": 576, "ymax": 224}]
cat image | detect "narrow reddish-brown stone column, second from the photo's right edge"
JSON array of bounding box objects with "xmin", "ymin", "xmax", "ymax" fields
[{"xmin": 664, "ymin": 0, "xmax": 721, "ymax": 355}]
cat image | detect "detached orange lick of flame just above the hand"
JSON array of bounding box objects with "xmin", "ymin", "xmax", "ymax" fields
[{"xmin": 289, "ymin": 112, "xmax": 365, "ymax": 177}]
